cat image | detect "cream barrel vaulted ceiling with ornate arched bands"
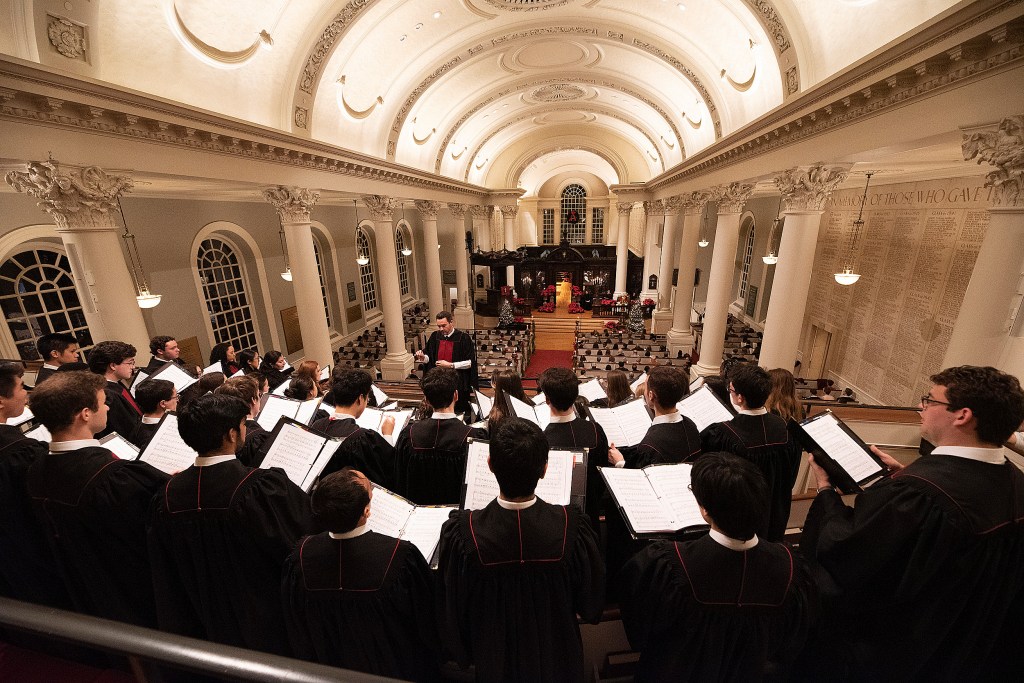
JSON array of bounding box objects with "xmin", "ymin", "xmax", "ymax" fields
[{"xmin": 0, "ymin": 0, "xmax": 957, "ymax": 194}]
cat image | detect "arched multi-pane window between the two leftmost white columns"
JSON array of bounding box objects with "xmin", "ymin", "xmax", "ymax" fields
[{"xmin": 196, "ymin": 238, "xmax": 257, "ymax": 350}]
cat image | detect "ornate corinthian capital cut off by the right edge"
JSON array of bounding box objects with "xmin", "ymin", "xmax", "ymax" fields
[{"xmin": 958, "ymin": 114, "xmax": 1024, "ymax": 207}]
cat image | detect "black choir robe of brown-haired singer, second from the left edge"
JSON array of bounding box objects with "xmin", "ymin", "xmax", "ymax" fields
[{"xmin": 27, "ymin": 446, "xmax": 167, "ymax": 628}]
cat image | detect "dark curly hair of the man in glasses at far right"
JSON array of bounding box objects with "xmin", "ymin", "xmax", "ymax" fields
[{"xmin": 929, "ymin": 366, "xmax": 1024, "ymax": 445}]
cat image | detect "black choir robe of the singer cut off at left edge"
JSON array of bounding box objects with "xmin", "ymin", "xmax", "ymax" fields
[{"xmin": 0, "ymin": 424, "xmax": 73, "ymax": 609}]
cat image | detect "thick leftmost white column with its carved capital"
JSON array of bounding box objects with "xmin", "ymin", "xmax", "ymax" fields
[{"xmin": 6, "ymin": 161, "xmax": 150, "ymax": 354}]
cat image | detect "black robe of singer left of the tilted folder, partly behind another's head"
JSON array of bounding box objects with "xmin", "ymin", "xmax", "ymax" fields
[{"xmin": 700, "ymin": 413, "xmax": 803, "ymax": 541}]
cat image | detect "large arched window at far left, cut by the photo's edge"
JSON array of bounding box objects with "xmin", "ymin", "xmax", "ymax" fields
[{"xmin": 0, "ymin": 248, "xmax": 92, "ymax": 360}]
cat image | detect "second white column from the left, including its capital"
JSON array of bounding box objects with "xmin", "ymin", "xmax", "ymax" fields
[{"xmin": 263, "ymin": 185, "xmax": 334, "ymax": 367}]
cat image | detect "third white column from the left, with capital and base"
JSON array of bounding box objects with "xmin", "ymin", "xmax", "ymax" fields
[{"xmin": 362, "ymin": 195, "xmax": 414, "ymax": 381}]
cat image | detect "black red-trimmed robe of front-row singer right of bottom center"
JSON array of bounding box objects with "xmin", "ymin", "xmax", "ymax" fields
[{"xmin": 620, "ymin": 536, "xmax": 811, "ymax": 682}]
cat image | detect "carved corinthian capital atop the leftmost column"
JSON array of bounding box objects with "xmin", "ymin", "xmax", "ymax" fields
[{"xmin": 6, "ymin": 161, "xmax": 134, "ymax": 230}]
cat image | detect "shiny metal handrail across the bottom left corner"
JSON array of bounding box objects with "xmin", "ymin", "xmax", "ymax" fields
[{"xmin": 0, "ymin": 598, "xmax": 395, "ymax": 683}]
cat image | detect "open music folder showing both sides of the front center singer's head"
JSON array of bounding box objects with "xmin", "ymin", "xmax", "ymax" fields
[{"xmin": 462, "ymin": 439, "xmax": 587, "ymax": 510}]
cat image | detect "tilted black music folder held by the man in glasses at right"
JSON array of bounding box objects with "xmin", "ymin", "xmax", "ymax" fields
[{"xmin": 790, "ymin": 411, "xmax": 889, "ymax": 494}]
